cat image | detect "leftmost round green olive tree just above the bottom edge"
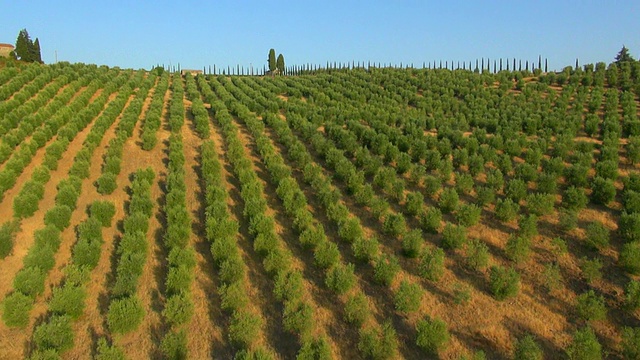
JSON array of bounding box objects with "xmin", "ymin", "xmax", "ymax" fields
[{"xmin": 33, "ymin": 316, "xmax": 74, "ymax": 352}]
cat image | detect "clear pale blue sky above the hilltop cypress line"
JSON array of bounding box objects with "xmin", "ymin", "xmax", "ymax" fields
[{"xmin": 0, "ymin": 0, "xmax": 640, "ymax": 69}]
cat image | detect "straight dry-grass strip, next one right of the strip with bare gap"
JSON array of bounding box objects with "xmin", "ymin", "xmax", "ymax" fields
[{"xmin": 182, "ymin": 104, "xmax": 226, "ymax": 359}]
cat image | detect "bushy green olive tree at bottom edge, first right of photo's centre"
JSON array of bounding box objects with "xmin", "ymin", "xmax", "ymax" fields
[{"xmin": 358, "ymin": 321, "xmax": 398, "ymax": 360}]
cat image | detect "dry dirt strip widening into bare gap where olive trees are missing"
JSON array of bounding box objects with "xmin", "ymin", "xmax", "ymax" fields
[{"xmin": 115, "ymin": 79, "xmax": 171, "ymax": 359}]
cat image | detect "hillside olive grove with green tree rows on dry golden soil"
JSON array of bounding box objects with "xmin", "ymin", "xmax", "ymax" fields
[{"xmin": 0, "ymin": 59, "xmax": 640, "ymax": 359}]
